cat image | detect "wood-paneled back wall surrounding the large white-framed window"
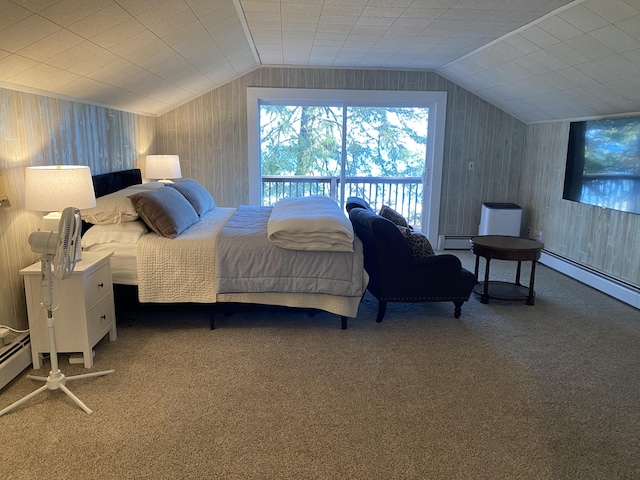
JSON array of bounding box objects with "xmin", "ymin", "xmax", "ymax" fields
[{"xmin": 157, "ymin": 67, "xmax": 524, "ymax": 235}]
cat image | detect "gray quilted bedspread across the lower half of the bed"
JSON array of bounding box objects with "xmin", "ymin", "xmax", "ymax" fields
[{"xmin": 215, "ymin": 205, "xmax": 366, "ymax": 297}]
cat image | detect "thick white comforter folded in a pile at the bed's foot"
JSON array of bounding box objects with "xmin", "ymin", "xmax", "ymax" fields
[{"xmin": 267, "ymin": 196, "xmax": 354, "ymax": 252}]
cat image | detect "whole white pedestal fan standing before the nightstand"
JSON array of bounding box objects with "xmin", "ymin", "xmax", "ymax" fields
[{"xmin": 0, "ymin": 207, "xmax": 115, "ymax": 416}]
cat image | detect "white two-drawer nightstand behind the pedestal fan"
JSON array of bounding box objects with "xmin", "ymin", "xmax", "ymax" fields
[{"xmin": 20, "ymin": 252, "xmax": 117, "ymax": 369}]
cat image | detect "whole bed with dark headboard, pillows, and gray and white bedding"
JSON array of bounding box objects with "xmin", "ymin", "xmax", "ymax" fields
[{"xmin": 82, "ymin": 169, "xmax": 367, "ymax": 329}]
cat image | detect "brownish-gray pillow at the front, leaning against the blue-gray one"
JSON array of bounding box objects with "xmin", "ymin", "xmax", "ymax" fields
[{"xmin": 129, "ymin": 188, "xmax": 200, "ymax": 238}]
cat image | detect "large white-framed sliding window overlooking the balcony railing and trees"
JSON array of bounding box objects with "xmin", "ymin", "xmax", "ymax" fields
[{"xmin": 247, "ymin": 88, "xmax": 446, "ymax": 241}]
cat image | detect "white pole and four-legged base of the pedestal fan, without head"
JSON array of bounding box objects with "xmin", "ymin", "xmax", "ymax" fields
[{"xmin": 0, "ymin": 253, "xmax": 115, "ymax": 416}]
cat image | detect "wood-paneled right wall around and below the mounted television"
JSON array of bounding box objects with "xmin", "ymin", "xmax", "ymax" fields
[{"xmin": 520, "ymin": 122, "xmax": 640, "ymax": 288}]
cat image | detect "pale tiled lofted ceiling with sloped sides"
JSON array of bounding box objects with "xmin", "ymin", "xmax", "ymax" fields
[{"xmin": 0, "ymin": 0, "xmax": 640, "ymax": 122}]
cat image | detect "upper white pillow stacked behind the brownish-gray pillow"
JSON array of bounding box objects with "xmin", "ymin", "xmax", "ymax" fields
[{"xmin": 80, "ymin": 182, "xmax": 164, "ymax": 225}]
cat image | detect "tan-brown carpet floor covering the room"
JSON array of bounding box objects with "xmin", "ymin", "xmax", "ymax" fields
[{"xmin": 0, "ymin": 251, "xmax": 640, "ymax": 480}]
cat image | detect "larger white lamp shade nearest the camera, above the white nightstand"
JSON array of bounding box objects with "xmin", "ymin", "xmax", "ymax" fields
[{"xmin": 25, "ymin": 165, "xmax": 96, "ymax": 212}]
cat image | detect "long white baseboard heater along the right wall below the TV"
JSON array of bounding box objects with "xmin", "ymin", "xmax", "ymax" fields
[{"xmin": 540, "ymin": 251, "xmax": 640, "ymax": 309}]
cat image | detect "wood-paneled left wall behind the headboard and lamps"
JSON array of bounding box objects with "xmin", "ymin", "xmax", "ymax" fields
[{"xmin": 0, "ymin": 88, "xmax": 156, "ymax": 328}]
